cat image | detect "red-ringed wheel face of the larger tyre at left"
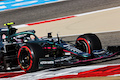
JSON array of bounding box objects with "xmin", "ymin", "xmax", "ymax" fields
[{"xmin": 18, "ymin": 46, "xmax": 33, "ymax": 71}]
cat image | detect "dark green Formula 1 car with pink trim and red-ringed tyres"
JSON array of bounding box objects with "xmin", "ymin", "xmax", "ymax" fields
[{"xmin": 0, "ymin": 22, "xmax": 119, "ymax": 72}]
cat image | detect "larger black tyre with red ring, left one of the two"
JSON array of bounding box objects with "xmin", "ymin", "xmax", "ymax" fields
[{"xmin": 17, "ymin": 43, "xmax": 44, "ymax": 72}]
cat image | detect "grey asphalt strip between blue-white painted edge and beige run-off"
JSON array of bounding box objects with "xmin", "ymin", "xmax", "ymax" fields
[{"xmin": 0, "ymin": 0, "xmax": 120, "ymax": 27}]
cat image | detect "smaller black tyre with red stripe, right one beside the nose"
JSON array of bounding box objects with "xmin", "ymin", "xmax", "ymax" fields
[{"xmin": 75, "ymin": 34, "xmax": 102, "ymax": 57}]
